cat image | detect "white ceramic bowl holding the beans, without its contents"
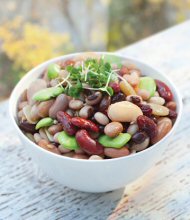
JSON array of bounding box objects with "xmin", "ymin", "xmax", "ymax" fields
[{"xmin": 9, "ymin": 53, "xmax": 182, "ymax": 192}]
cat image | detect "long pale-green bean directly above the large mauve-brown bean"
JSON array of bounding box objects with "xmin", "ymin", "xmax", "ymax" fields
[{"xmin": 33, "ymin": 87, "xmax": 64, "ymax": 101}]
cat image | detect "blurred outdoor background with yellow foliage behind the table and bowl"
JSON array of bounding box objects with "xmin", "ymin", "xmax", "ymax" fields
[{"xmin": 0, "ymin": 0, "xmax": 190, "ymax": 100}]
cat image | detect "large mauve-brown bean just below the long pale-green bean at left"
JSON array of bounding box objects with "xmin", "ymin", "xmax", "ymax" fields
[{"xmin": 49, "ymin": 94, "xmax": 69, "ymax": 118}]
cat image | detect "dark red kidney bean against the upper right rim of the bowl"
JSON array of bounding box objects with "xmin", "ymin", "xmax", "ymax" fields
[{"xmin": 155, "ymin": 80, "xmax": 173, "ymax": 102}]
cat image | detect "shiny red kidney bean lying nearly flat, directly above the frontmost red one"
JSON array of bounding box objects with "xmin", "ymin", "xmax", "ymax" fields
[{"xmin": 71, "ymin": 117, "xmax": 99, "ymax": 132}]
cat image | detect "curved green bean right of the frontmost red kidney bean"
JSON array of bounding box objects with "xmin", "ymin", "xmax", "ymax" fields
[{"xmin": 98, "ymin": 133, "xmax": 131, "ymax": 148}]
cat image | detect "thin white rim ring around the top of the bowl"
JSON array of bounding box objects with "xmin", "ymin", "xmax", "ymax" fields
[{"xmin": 9, "ymin": 51, "xmax": 182, "ymax": 163}]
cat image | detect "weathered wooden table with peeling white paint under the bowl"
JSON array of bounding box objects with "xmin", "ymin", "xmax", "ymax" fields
[{"xmin": 0, "ymin": 21, "xmax": 190, "ymax": 220}]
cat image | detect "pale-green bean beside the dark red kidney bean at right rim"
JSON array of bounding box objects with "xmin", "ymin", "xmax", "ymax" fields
[{"xmin": 139, "ymin": 76, "xmax": 156, "ymax": 97}]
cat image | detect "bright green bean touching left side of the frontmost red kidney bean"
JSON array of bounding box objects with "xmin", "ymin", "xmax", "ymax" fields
[{"xmin": 57, "ymin": 131, "xmax": 79, "ymax": 150}]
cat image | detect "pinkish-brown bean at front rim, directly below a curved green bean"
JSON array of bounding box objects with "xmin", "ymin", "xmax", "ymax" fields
[{"xmin": 104, "ymin": 147, "xmax": 130, "ymax": 158}]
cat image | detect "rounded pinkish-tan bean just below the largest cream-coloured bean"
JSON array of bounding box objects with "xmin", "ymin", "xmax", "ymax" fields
[{"xmin": 104, "ymin": 122, "xmax": 123, "ymax": 137}]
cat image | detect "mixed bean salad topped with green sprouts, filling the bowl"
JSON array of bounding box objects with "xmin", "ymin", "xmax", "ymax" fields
[{"xmin": 17, "ymin": 55, "xmax": 177, "ymax": 160}]
